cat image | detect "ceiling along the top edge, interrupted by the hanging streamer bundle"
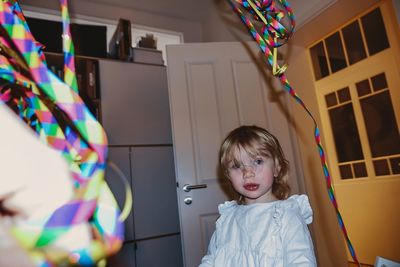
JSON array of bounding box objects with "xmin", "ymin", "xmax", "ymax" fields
[{"xmin": 81, "ymin": 0, "xmax": 337, "ymax": 27}]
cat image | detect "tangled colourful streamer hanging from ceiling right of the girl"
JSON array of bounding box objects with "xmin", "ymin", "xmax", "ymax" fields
[{"xmin": 228, "ymin": 0, "xmax": 360, "ymax": 266}]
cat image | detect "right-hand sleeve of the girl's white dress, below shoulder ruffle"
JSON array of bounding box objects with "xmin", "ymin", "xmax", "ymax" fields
[{"xmin": 282, "ymin": 210, "xmax": 317, "ymax": 267}]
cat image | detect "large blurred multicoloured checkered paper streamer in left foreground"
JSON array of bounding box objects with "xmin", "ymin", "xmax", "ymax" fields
[{"xmin": 0, "ymin": 0, "xmax": 129, "ymax": 266}]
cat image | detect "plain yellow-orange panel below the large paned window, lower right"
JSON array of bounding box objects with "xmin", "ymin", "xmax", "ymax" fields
[{"xmin": 335, "ymin": 180, "xmax": 400, "ymax": 264}]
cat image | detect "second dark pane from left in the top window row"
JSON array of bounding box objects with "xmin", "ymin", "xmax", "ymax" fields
[{"xmin": 325, "ymin": 32, "xmax": 347, "ymax": 73}]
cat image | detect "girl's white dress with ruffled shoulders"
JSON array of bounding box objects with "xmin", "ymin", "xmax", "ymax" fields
[{"xmin": 199, "ymin": 195, "xmax": 317, "ymax": 267}]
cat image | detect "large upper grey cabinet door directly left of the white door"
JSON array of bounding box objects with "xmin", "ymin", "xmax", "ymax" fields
[{"xmin": 99, "ymin": 60, "xmax": 172, "ymax": 145}]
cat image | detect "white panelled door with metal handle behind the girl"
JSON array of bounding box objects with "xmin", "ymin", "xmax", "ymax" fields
[{"xmin": 167, "ymin": 43, "xmax": 303, "ymax": 267}]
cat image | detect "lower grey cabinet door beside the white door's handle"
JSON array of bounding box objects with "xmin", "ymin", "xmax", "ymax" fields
[{"xmin": 131, "ymin": 146, "xmax": 179, "ymax": 240}]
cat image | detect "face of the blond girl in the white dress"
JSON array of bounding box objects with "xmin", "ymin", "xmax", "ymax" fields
[{"xmin": 228, "ymin": 149, "xmax": 280, "ymax": 205}]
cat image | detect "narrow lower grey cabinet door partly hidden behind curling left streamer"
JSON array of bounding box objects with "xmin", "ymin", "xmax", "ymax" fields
[{"xmin": 105, "ymin": 147, "xmax": 134, "ymax": 241}]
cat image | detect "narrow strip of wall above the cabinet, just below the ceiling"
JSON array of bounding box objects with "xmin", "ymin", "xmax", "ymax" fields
[{"xmin": 19, "ymin": 0, "xmax": 203, "ymax": 42}]
